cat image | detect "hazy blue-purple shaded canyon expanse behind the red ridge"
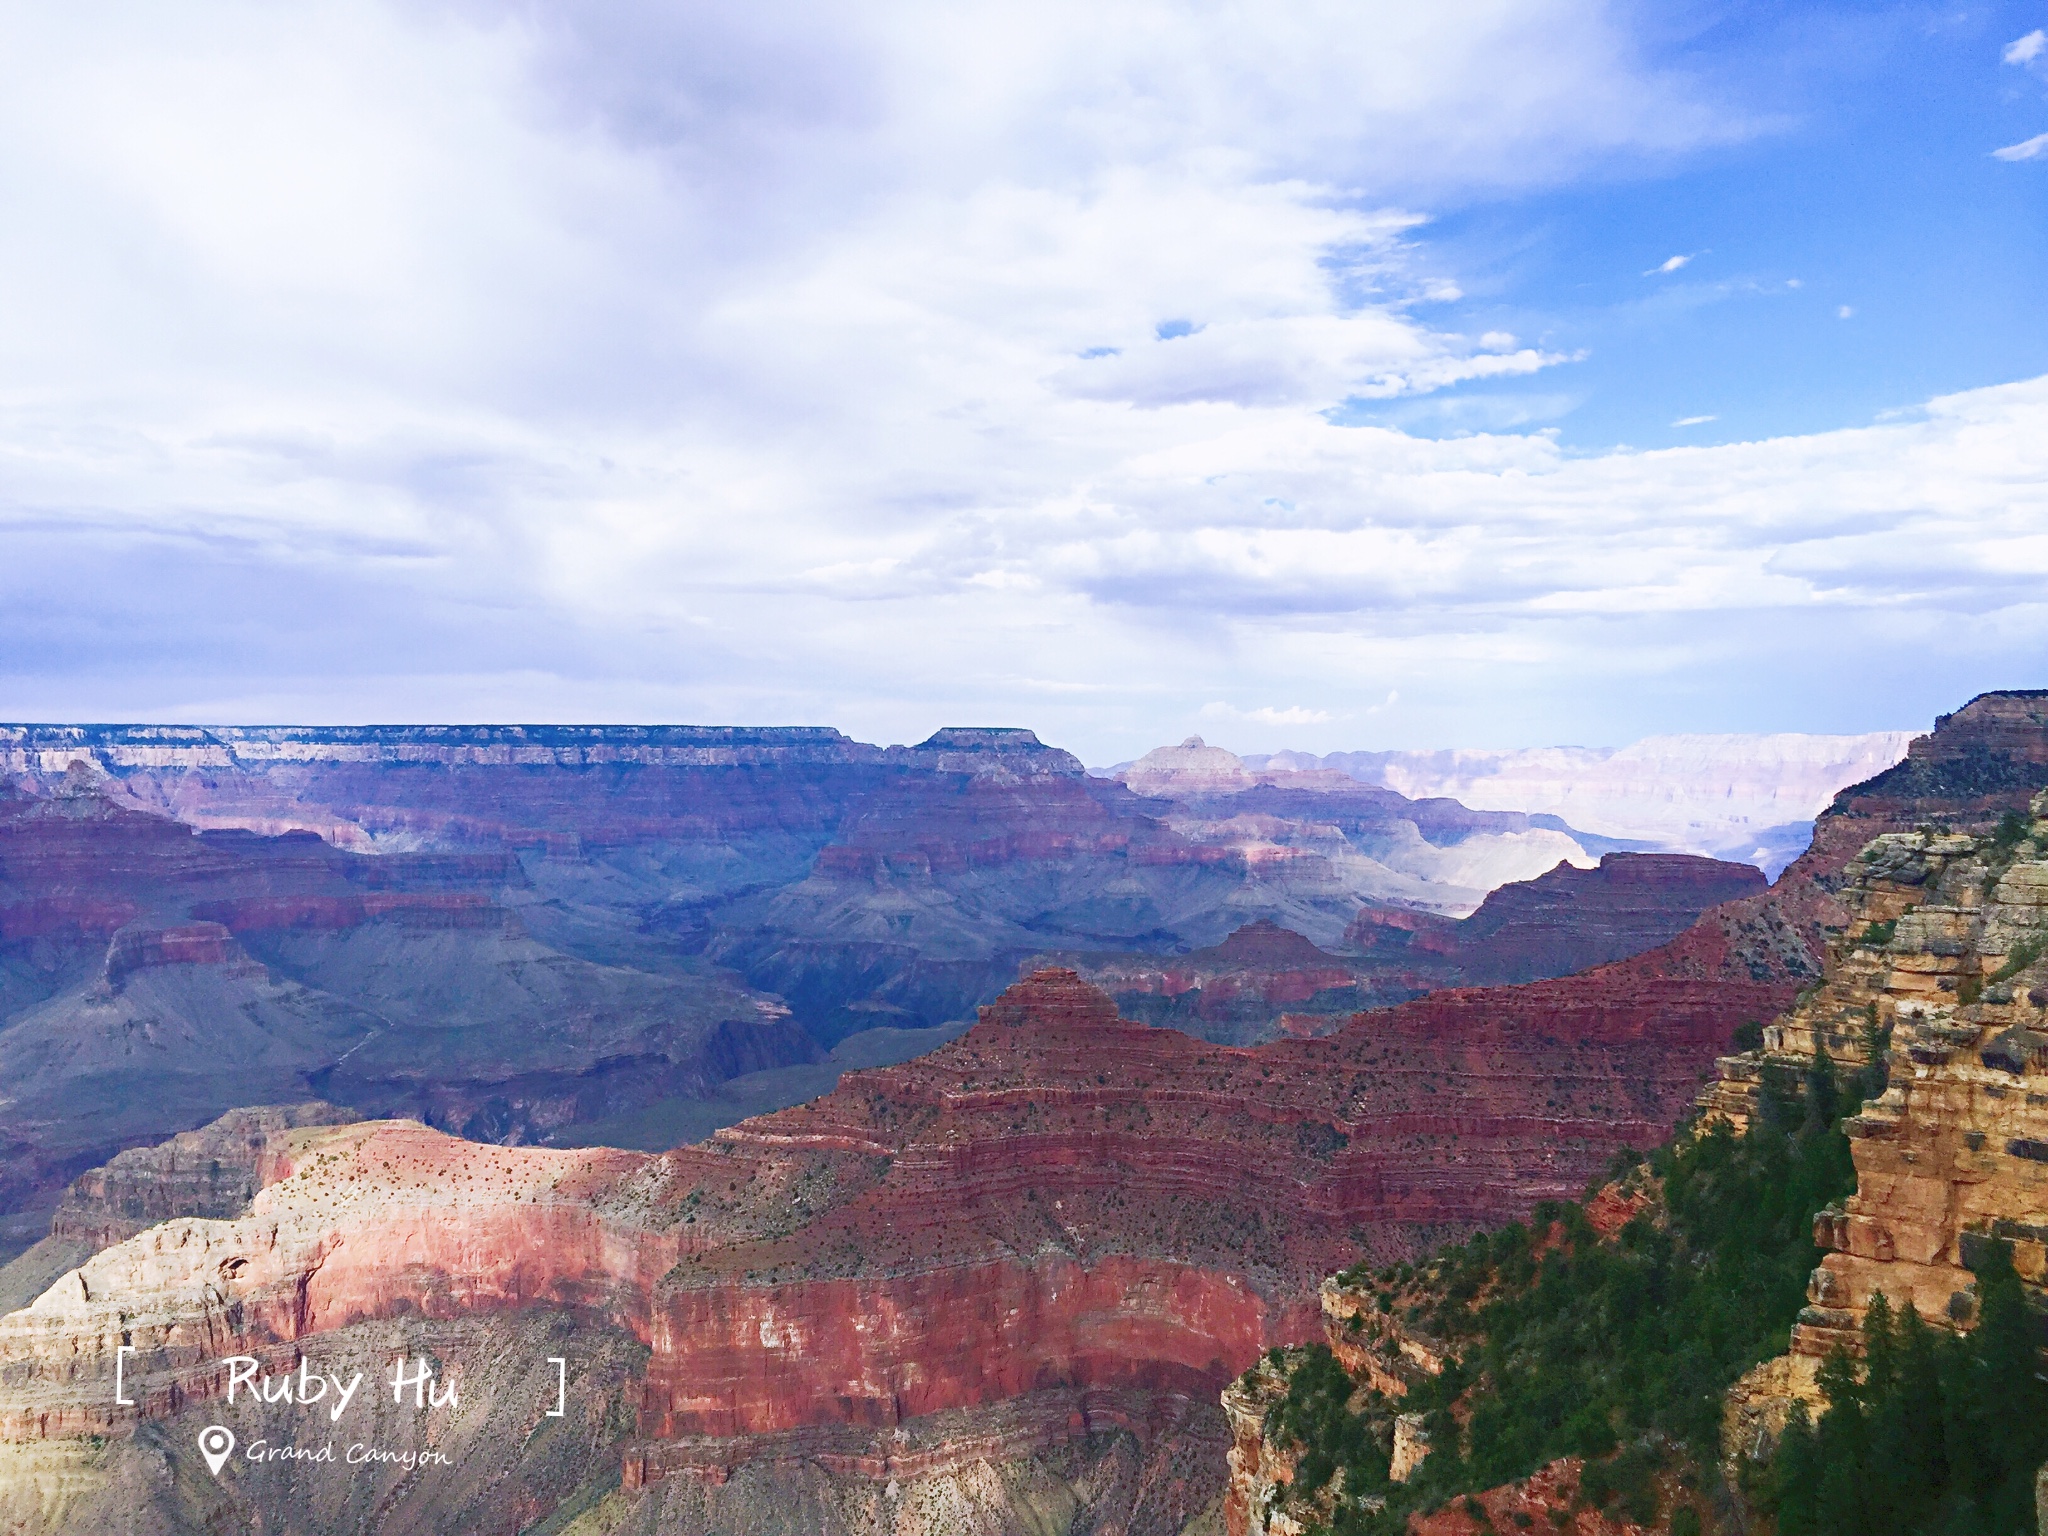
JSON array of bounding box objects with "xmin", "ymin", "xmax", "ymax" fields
[{"xmin": 0, "ymin": 727, "xmax": 1761, "ymax": 1253}]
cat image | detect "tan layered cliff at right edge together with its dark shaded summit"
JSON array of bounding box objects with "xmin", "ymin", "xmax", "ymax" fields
[{"xmin": 1702, "ymin": 690, "xmax": 2048, "ymax": 1456}]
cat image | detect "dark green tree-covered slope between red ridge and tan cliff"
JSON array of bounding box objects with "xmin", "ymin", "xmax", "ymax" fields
[{"xmin": 1268, "ymin": 1059, "xmax": 1876, "ymax": 1536}]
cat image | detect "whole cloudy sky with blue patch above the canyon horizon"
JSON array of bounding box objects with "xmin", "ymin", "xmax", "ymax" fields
[{"xmin": 0, "ymin": 0, "xmax": 2048, "ymax": 762}]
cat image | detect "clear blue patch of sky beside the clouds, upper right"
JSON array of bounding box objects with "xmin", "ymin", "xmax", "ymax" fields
[{"xmin": 1348, "ymin": 4, "xmax": 2048, "ymax": 451}]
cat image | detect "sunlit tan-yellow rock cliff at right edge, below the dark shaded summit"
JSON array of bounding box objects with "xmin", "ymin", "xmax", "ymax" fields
[{"xmin": 1706, "ymin": 797, "xmax": 2048, "ymax": 1450}]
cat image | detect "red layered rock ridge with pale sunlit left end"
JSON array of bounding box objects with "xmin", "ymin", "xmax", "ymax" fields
[{"xmin": 0, "ymin": 946, "xmax": 1794, "ymax": 1528}]
